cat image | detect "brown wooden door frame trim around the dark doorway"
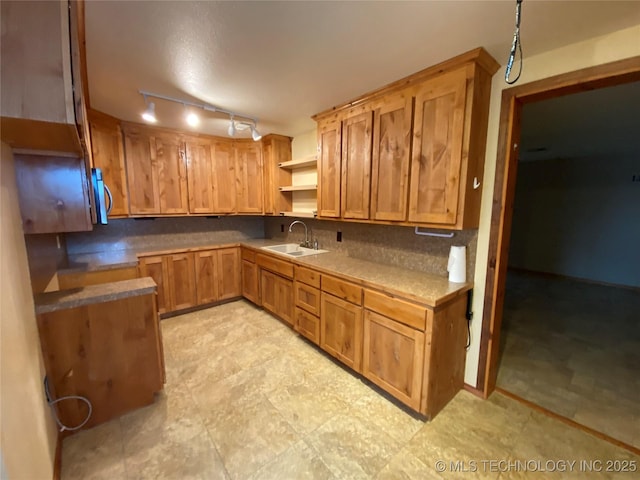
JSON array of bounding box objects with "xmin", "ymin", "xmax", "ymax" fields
[{"xmin": 477, "ymin": 57, "xmax": 640, "ymax": 450}]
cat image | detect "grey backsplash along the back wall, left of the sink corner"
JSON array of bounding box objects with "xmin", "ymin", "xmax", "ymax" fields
[{"xmin": 66, "ymin": 216, "xmax": 264, "ymax": 255}]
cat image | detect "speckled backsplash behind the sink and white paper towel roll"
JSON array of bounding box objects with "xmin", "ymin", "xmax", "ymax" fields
[{"xmin": 265, "ymin": 217, "xmax": 478, "ymax": 280}]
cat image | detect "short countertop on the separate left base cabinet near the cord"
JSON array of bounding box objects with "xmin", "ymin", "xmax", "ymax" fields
[{"xmin": 34, "ymin": 277, "xmax": 157, "ymax": 315}]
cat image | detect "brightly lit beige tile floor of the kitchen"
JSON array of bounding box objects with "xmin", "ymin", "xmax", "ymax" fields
[{"xmin": 62, "ymin": 301, "xmax": 640, "ymax": 480}]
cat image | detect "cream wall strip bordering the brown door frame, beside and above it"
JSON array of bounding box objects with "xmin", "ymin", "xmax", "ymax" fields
[{"xmin": 465, "ymin": 25, "xmax": 640, "ymax": 385}]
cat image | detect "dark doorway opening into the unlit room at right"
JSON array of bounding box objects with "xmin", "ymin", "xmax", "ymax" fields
[{"xmin": 496, "ymin": 82, "xmax": 640, "ymax": 448}]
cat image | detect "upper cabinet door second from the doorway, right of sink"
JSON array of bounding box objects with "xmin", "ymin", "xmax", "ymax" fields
[{"xmin": 371, "ymin": 95, "xmax": 413, "ymax": 221}]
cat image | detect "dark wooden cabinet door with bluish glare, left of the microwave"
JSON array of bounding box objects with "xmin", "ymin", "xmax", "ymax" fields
[{"xmin": 15, "ymin": 154, "xmax": 93, "ymax": 233}]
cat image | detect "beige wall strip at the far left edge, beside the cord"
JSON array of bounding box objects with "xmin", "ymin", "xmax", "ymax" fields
[{"xmin": 0, "ymin": 143, "xmax": 57, "ymax": 479}]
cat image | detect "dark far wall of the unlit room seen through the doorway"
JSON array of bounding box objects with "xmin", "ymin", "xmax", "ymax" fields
[{"xmin": 509, "ymin": 156, "xmax": 640, "ymax": 287}]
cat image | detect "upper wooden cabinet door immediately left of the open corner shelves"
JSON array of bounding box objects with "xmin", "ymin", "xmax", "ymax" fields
[{"xmin": 235, "ymin": 141, "xmax": 263, "ymax": 213}]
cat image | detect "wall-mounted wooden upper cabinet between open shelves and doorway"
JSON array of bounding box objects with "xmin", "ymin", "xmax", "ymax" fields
[{"xmin": 313, "ymin": 48, "xmax": 499, "ymax": 230}]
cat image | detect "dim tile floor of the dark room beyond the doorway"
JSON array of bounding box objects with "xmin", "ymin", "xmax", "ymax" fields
[{"xmin": 497, "ymin": 271, "xmax": 640, "ymax": 448}]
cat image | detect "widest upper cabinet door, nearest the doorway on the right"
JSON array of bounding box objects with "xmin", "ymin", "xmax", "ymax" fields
[{"xmin": 409, "ymin": 69, "xmax": 466, "ymax": 225}]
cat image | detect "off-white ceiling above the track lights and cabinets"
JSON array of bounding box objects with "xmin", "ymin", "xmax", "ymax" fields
[{"xmin": 86, "ymin": 0, "xmax": 640, "ymax": 136}]
